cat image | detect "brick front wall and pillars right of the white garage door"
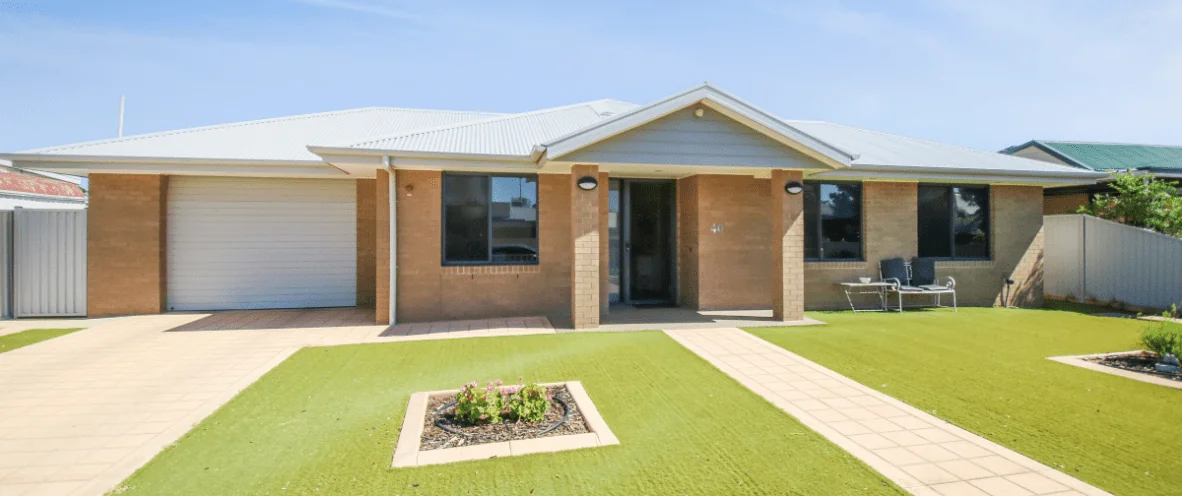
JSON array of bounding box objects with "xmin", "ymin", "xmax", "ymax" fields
[{"xmin": 371, "ymin": 172, "xmax": 1043, "ymax": 327}]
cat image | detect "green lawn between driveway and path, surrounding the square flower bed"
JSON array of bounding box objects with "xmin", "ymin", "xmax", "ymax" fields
[{"xmin": 115, "ymin": 332, "xmax": 903, "ymax": 495}]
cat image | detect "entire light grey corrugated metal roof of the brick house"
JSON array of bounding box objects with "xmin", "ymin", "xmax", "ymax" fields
[{"xmin": 8, "ymin": 85, "xmax": 1095, "ymax": 181}]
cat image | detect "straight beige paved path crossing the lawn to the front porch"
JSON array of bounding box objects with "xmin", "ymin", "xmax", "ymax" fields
[{"xmin": 665, "ymin": 327, "xmax": 1108, "ymax": 496}]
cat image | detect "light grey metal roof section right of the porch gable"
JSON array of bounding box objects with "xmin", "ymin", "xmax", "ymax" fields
[{"xmin": 785, "ymin": 120, "xmax": 1096, "ymax": 174}]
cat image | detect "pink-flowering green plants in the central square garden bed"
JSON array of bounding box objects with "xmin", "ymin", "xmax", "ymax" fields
[{"xmin": 455, "ymin": 379, "xmax": 552, "ymax": 424}]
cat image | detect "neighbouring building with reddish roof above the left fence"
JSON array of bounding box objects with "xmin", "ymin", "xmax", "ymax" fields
[{"xmin": 0, "ymin": 161, "xmax": 86, "ymax": 211}]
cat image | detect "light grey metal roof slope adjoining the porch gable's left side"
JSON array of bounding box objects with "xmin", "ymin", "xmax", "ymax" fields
[{"xmin": 349, "ymin": 100, "xmax": 637, "ymax": 157}]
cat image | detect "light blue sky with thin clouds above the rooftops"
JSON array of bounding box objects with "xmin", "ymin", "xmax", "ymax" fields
[{"xmin": 0, "ymin": 0, "xmax": 1182, "ymax": 151}]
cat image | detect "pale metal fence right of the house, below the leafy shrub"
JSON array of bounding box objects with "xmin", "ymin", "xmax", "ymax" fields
[{"xmin": 1044, "ymin": 215, "xmax": 1182, "ymax": 308}]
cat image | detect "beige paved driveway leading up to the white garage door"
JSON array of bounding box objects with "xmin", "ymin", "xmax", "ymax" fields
[{"xmin": 0, "ymin": 309, "xmax": 553, "ymax": 496}]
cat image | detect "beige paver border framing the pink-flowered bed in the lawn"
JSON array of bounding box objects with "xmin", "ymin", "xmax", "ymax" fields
[{"xmin": 392, "ymin": 380, "xmax": 619, "ymax": 469}]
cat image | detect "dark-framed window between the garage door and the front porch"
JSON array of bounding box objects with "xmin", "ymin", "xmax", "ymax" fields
[{"xmin": 443, "ymin": 174, "xmax": 538, "ymax": 265}]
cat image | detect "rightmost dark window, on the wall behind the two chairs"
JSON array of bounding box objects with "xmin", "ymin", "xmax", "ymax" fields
[{"xmin": 918, "ymin": 184, "xmax": 989, "ymax": 260}]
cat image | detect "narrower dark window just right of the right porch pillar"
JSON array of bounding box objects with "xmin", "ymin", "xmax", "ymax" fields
[{"xmin": 804, "ymin": 183, "xmax": 862, "ymax": 260}]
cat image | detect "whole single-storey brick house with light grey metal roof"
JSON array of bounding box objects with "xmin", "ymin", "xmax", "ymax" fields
[{"xmin": 2, "ymin": 85, "xmax": 1104, "ymax": 328}]
